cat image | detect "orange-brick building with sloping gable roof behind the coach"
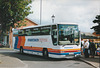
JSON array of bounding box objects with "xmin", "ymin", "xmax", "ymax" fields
[{"xmin": 9, "ymin": 18, "xmax": 38, "ymax": 48}]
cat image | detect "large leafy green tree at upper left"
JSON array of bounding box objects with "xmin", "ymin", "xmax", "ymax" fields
[{"xmin": 0, "ymin": 0, "xmax": 32, "ymax": 32}]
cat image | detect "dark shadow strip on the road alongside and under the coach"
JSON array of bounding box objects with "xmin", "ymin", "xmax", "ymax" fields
[{"xmin": 0, "ymin": 50, "xmax": 80, "ymax": 61}]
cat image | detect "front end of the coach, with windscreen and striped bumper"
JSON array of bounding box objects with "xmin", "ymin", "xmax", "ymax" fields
[{"xmin": 58, "ymin": 24, "xmax": 81, "ymax": 58}]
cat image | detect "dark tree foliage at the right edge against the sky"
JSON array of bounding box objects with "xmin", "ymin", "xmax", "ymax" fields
[{"xmin": 91, "ymin": 15, "xmax": 100, "ymax": 34}]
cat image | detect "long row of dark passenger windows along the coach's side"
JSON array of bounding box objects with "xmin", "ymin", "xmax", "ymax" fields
[{"xmin": 19, "ymin": 26, "xmax": 51, "ymax": 36}]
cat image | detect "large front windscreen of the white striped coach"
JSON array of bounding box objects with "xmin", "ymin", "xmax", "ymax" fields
[{"xmin": 58, "ymin": 24, "xmax": 79, "ymax": 45}]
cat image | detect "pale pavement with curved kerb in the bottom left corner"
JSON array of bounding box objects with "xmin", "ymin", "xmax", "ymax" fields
[{"xmin": 0, "ymin": 48, "xmax": 28, "ymax": 68}]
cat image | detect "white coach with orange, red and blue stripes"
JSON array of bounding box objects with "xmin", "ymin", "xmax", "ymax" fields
[{"xmin": 14, "ymin": 23, "xmax": 81, "ymax": 58}]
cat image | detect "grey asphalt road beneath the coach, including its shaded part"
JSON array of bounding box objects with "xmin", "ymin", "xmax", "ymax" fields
[{"xmin": 0, "ymin": 49, "xmax": 93, "ymax": 68}]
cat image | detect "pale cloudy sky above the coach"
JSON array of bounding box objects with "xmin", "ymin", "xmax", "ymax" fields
[{"xmin": 28, "ymin": 0, "xmax": 100, "ymax": 33}]
